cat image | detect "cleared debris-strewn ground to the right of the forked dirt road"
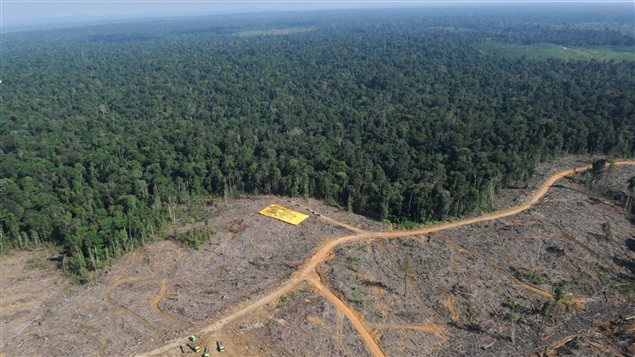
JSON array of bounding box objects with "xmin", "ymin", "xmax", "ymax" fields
[{"xmin": 319, "ymin": 166, "xmax": 635, "ymax": 356}]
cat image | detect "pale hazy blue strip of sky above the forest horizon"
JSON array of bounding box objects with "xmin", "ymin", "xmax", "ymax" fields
[{"xmin": 0, "ymin": 0, "xmax": 628, "ymax": 28}]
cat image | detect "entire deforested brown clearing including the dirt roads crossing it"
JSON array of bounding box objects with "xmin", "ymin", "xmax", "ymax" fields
[{"xmin": 0, "ymin": 160, "xmax": 635, "ymax": 356}]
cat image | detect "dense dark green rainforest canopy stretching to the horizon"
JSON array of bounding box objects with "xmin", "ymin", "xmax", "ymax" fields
[{"xmin": 0, "ymin": 6, "xmax": 635, "ymax": 278}]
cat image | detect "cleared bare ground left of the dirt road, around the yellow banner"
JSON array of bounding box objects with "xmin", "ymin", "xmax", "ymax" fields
[{"xmin": 0, "ymin": 196, "xmax": 368, "ymax": 356}]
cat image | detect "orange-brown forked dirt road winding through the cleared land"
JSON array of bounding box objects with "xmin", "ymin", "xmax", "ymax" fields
[{"xmin": 139, "ymin": 160, "xmax": 635, "ymax": 356}]
